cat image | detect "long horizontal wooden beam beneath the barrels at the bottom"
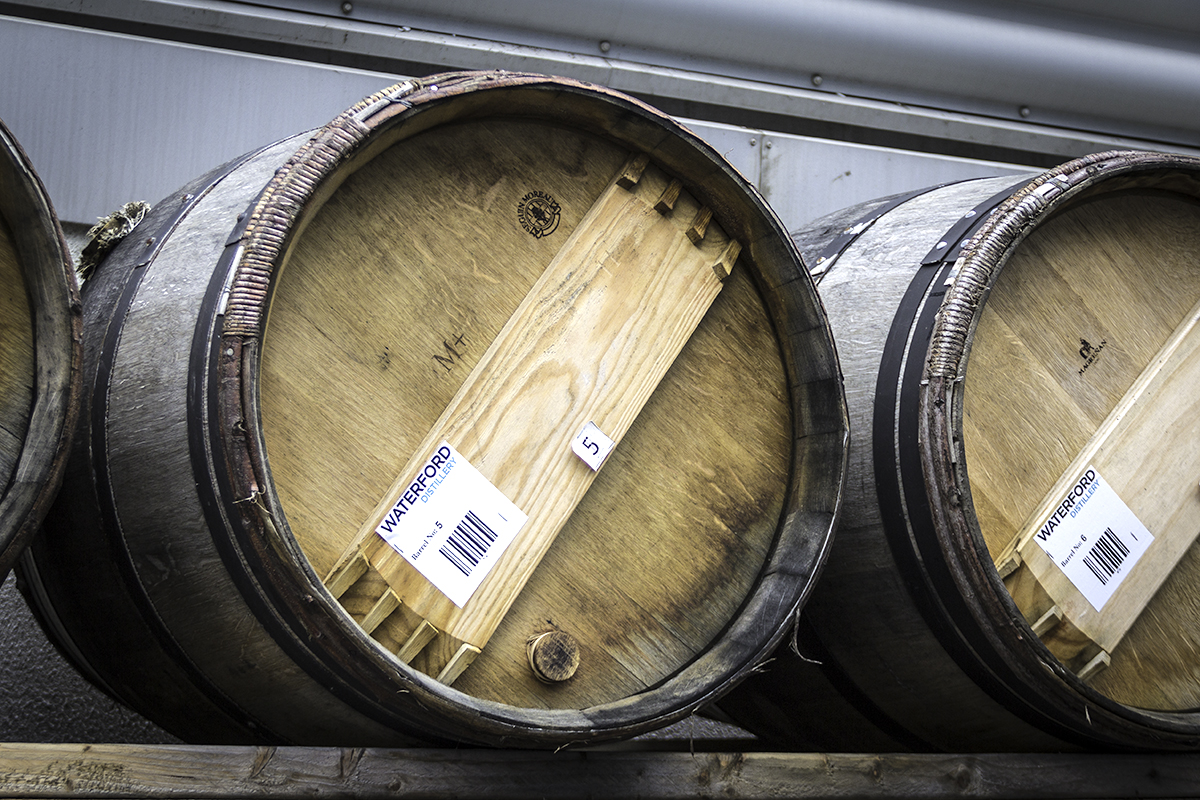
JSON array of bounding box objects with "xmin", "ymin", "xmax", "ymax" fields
[{"xmin": 0, "ymin": 744, "xmax": 1200, "ymax": 800}]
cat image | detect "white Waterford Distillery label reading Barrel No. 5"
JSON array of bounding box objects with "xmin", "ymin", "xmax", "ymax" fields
[{"xmin": 376, "ymin": 441, "xmax": 529, "ymax": 608}]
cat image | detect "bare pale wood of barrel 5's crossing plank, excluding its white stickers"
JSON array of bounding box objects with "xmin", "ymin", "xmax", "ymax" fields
[{"xmin": 319, "ymin": 154, "xmax": 725, "ymax": 662}]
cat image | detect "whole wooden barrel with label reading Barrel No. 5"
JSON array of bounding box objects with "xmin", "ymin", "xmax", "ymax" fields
[{"xmin": 18, "ymin": 73, "xmax": 847, "ymax": 747}]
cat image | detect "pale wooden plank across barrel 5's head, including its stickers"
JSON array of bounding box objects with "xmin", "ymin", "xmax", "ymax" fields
[{"xmin": 326, "ymin": 154, "xmax": 740, "ymax": 684}]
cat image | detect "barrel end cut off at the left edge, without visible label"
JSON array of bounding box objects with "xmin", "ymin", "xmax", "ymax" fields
[{"xmin": 0, "ymin": 122, "xmax": 82, "ymax": 581}]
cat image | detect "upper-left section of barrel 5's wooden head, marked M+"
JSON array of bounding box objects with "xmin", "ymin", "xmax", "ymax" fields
[{"xmin": 262, "ymin": 121, "xmax": 626, "ymax": 575}]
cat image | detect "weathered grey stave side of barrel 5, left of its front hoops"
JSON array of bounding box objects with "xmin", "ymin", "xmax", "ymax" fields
[{"xmin": 23, "ymin": 128, "xmax": 419, "ymax": 746}]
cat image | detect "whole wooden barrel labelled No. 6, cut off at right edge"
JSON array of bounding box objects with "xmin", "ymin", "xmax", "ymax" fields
[{"xmin": 722, "ymin": 152, "xmax": 1200, "ymax": 751}]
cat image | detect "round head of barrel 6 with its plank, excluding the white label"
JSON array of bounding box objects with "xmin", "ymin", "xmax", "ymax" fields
[{"xmin": 962, "ymin": 192, "xmax": 1200, "ymax": 709}]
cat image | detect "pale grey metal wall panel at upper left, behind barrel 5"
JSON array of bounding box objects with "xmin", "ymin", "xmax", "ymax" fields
[{"xmin": 0, "ymin": 17, "xmax": 397, "ymax": 223}]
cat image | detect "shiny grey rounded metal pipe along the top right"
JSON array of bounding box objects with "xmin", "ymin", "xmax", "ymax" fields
[{"xmin": 343, "ymin": 0, "xmax": 1200, "ymax": 137}]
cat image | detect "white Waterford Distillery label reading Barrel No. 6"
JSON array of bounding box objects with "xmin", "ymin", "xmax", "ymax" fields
[{"xmin": 1033, "ymin": 467, "xmax": 1154, "ymax": 610}]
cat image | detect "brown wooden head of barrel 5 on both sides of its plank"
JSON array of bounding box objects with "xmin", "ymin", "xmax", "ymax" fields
[{"xmin": 262, "ymin": 120, "xmax": 792, "ymax": 708}]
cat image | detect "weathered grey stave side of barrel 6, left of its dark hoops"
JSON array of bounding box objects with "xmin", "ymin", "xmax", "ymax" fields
[{"xmin": 721, "ymin": 179, "xmax": 1064, "ymax": 750}]
